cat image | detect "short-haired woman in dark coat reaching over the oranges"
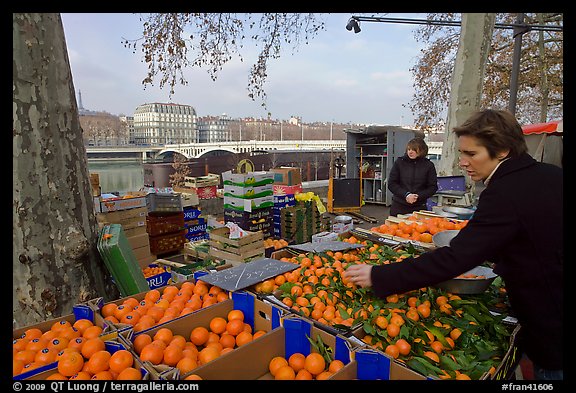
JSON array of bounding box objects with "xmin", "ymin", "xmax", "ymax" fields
[{"xmin": 346, "ymin": 110, "xmax": 566, "ymax": 379}]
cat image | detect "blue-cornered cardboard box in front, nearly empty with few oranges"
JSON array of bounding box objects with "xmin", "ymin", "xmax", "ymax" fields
[{"xmin": 181, "ymin": 314, "xmax": 357, "ymax": 380}]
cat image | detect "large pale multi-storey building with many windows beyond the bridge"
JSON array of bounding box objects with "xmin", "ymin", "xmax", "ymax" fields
[{"xmin": 134, "ymin": 102, "xmax": 198, "ymax": 145}]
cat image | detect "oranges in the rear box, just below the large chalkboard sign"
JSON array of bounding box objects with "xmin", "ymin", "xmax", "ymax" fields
[{"xmin": 100, "ymin": 281, "xmax": 230, "ymax": 332}]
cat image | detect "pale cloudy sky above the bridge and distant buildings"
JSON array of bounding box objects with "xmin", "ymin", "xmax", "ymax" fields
[{"xmin": 61, "ymin": 13, "xmax": 425, "ymax": 126}]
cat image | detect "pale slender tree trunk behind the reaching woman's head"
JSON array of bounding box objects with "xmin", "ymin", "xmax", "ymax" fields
[{"xmin": 438, "ymin": 13, "xmax": 495, "ymax": 176}]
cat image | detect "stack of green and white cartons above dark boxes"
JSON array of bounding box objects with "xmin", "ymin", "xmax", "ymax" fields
[{"xmin": 222, "ymin": 171, "xmax": 274, "ymax": 237}]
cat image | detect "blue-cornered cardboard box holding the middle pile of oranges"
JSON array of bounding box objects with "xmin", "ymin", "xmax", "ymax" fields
[{"xmin": 132, "ymin": 291, "xmax": 286, "ymax": 380}]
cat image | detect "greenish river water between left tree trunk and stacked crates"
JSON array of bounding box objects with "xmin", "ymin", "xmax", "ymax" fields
[{"xmin": 88, "ymin": 160, "xmax": 144, "ymax": 193}]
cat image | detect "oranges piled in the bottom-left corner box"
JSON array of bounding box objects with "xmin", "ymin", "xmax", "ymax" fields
[{"xmin": 12, "ymin": 319, "xmax": 141, "ymax": 379}]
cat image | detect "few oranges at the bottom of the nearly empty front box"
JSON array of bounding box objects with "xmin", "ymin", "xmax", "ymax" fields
[{"xmin": 268, "ymin": 352, "xmax": 344, "ymax": 380}]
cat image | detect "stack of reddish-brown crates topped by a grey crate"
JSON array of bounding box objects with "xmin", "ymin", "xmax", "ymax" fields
[{"xmin": 146, "ymin": 193, "xmax": 186, "ymax": 256}]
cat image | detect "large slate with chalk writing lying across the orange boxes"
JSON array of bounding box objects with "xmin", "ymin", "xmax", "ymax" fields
[{"xmin": 198, "ymin": 258, "xmax": 300, "ymax": 292}]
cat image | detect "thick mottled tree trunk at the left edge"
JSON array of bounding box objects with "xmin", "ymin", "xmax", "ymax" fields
[{"xmin": 12, "ymin": 13, "xmax": 118, "ymax": 328}]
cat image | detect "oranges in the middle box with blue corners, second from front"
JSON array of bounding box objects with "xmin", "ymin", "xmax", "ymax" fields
[{"xmin": 133, "ymin": 310, "xmax": 266, "ymax": 377}]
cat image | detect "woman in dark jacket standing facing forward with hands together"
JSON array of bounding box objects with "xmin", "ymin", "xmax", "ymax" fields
[{"xmin": 388, "ymin": 138, "xmax": 438, "ymax": 216}]
